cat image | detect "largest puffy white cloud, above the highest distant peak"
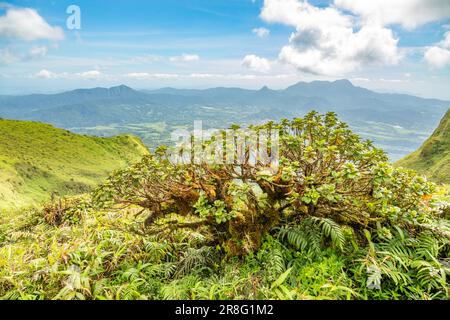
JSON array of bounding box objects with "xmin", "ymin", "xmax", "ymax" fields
[{"xmin": 261, "ymin": 0, "xmax": 401, "ymax": 76}]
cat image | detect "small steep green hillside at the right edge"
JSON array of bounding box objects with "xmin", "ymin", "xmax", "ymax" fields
[{"xmin": 396, "ymin": 109, "xmax": 450, "ymax": 184}]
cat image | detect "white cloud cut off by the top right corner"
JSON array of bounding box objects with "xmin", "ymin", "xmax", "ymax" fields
[{"xmin": 334, "ymin": 0, "xmax": 450, "ymax": 29}]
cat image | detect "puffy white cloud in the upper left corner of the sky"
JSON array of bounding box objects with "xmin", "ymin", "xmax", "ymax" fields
[{"xmin": 0, "ymin": 7, "xmax": 64, "ymax": 41}]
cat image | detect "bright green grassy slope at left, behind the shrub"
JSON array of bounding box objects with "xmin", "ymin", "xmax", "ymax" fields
[{"xmin": 0, "ymin": 119, "xmax": 148, "ymax": 209}]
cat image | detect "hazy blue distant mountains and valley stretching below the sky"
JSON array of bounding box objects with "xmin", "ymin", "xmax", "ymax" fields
[{"xmin": 0, "ymin": 80, "xmax": 450, "ymax": 159}]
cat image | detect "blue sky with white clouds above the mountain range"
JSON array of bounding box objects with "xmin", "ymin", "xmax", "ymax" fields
[{"xmin": 0, "ymin": 0, "xmax": 450, "ymax": 100}]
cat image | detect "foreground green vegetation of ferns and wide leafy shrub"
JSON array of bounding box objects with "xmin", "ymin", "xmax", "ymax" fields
[{"xmin": 0, "ymin": 112, "xmax": 450, "ymax": 299}]
